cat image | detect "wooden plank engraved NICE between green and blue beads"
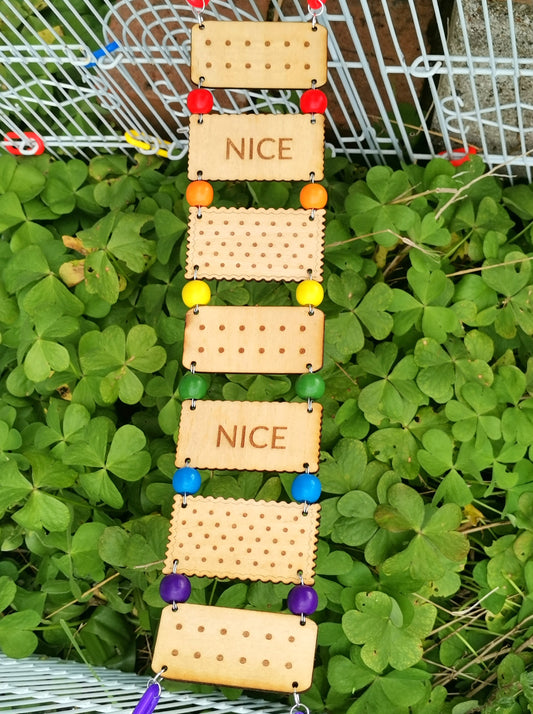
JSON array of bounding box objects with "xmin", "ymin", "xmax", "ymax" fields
[{"xmin": 176, "ymin": 399, "xmax": 322, "ymax": 473}]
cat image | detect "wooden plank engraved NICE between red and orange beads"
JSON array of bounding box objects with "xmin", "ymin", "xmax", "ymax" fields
[{"xmin": 189, "ymin": 114, "xmax": 324, "ymax": 181}]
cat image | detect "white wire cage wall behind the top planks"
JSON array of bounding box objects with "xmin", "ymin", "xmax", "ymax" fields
[{"xmin": 0, "ymin": 0, "xmax": 533, "ymax": 180}]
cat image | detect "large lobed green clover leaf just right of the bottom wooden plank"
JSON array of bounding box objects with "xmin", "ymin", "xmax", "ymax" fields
[{"xmin": 342, "ymin": 591, "xmax": 437, "ymax": 672}]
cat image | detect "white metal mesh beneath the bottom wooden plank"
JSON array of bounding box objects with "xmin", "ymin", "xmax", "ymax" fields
[{"xmin": 0, "ymin": 654, "xmax": 290, "ymax": 714}]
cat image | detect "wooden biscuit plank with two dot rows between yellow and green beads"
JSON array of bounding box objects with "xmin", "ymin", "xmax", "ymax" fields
[{"xmin": 183, "ymin": 305, "xmax": 324, "ymax": 374}]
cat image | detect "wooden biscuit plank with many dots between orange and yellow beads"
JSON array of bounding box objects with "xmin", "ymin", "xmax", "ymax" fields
[{"xmin": 185, "ymin": 207, "xmax": 325, "ymax": 282}]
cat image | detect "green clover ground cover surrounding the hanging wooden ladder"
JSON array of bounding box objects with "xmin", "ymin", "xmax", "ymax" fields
[{"xmin": 0, "ymin": 147, "xmax": 533, "ymax": 714}]
